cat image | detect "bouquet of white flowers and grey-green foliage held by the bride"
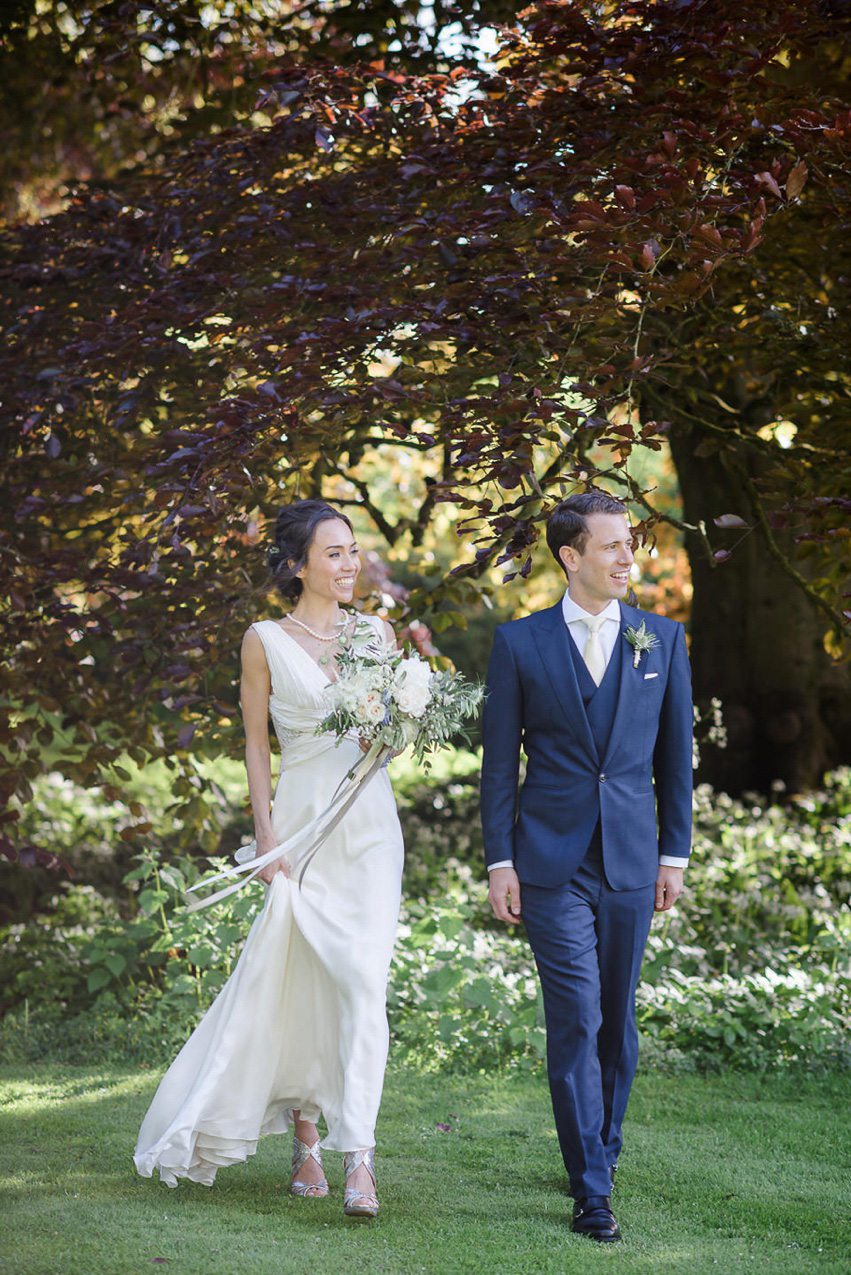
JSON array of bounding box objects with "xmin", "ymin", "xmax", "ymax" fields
[{"xmin": 316, "ymin": 621, "xmax": 484, "ymax": 768}]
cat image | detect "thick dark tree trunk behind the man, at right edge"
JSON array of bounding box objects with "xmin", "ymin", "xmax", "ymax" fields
[{"xmin": 671, "ymin": 426, "xmax": 851, "ymax": 793}]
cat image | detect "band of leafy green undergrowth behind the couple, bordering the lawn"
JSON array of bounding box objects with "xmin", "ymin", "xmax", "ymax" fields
[{"xmin": 0, "ymin": 755, "xmax": 851, "ymax": 1071}]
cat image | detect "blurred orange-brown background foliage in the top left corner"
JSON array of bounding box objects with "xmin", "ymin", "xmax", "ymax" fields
[{"xmin": 0, "ymin": 0, "xmax": 515, "ymax": 221}]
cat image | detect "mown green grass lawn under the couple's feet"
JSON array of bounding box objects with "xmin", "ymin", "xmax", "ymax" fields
[{"xmin": 0, "ymin": 1065, "xmax": 851, "ymax": 1275}]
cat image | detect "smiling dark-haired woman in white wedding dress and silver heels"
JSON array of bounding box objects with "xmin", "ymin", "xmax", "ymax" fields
[{"xmin": 134, "ymin": 500, "xmax": 403, "ymax": 1216}]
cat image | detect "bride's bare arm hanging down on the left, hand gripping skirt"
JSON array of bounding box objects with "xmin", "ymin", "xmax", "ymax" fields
[{"xmin": 240, "ymin": 629, "xmax": 287, "ymax": 884}]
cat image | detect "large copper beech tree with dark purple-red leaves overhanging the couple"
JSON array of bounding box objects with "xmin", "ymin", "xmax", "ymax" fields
[{"xmin": 0, "ymin": 0, "xmax": 851, "ymax": 867}]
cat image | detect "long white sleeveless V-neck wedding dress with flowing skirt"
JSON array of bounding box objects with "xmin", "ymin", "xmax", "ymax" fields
[{"xmin": 134, "ymin": 617, "xmax": 403, "ymax": 1187}]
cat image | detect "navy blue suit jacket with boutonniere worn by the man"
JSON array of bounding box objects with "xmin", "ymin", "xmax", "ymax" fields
[{"xmin": 481, "ymin": 602, "xmax": 693, "ymax": 890}]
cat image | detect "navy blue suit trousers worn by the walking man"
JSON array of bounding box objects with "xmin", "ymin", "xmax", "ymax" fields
[{"xmin": 521, "ymin": 835, "xmax": 656, "ymax": 1199}]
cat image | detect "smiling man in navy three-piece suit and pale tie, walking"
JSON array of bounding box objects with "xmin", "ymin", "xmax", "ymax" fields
[{"xmin": 481, "ymin": 491, "xmax": 692, "ymax": 1243}]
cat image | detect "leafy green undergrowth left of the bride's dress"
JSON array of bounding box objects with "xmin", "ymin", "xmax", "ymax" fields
[{"xmin": 0, "ymin": 849, "xmax": 259, "ymax": 1060}]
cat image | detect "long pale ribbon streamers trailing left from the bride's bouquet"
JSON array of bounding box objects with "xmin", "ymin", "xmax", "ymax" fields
[{"xmin": 186, "ymin": 740, "xmax": 393, "ymax": 912}]
